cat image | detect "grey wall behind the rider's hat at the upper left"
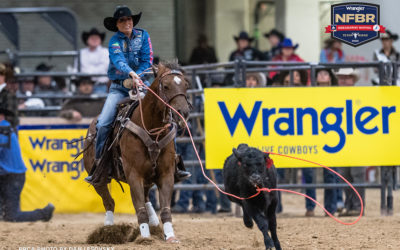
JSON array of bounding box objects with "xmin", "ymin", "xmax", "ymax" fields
[{"xmin": 0, "ymin": 0, "xmax": 176, "ymax": 71}]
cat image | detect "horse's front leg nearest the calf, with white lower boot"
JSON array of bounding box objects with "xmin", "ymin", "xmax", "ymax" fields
[{"xmin": 157, "ymin": 160, "xmax": 179, "ymax": 243}]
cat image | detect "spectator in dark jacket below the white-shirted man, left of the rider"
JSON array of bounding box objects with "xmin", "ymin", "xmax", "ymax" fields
[{"xmin": 60, "ymin": 77, "xmax": 104, "ymax": 122}]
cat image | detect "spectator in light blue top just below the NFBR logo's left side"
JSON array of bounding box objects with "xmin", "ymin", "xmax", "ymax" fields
[{"xmin": 319, "ymin": 38, "xmax": 345, "ymax": 63}]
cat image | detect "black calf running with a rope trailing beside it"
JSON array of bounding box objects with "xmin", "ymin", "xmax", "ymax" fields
[{"xmin": 223, "ymin": 144, "xmax": 281, "ymax": 249}]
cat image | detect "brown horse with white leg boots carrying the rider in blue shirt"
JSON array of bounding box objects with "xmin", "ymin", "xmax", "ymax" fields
[{"xmin": 83, "ymin": 63, "xmax": 190, "ymax": 242}]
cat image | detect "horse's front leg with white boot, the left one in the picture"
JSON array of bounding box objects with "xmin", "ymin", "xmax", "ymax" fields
[{"xmin": 127, "ymin": 174, "xmax": 150, "ymax": 238}]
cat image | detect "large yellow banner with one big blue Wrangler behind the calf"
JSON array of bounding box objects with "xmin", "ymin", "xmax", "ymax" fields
[{"xmin": 205, "ymin": 86, "xmax": 400, "ymax": 168}]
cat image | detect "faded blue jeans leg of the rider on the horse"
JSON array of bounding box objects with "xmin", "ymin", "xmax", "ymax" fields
[{"xmin": 96, "ymin": 83, "xmax": 129, "ymax": 159}]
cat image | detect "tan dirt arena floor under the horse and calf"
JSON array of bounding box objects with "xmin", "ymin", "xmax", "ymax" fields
[{"xmin": 0, "ymin": 190, "xmax": 400, "ymax": 250}]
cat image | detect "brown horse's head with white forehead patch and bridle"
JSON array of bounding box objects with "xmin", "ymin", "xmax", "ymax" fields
[{"xmin": 153, "ymin": 63, "xmax": 191, "ymax": 127}]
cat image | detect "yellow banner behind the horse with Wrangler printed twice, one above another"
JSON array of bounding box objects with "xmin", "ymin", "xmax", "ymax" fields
[{"xmin": 18, "ymin": 125, "xmax": 134, "ymax": 213}]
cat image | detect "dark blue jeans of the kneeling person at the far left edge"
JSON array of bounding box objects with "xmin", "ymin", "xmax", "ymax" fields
[{"xmin": 0, "ymin": 173, "xmax": 44, "ymax": 222}]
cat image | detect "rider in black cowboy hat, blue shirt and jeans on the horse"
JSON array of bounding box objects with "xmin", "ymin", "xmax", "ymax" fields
[{"xmin": 85, "ymin": 6, "xmax": 190, "ymax": 183}]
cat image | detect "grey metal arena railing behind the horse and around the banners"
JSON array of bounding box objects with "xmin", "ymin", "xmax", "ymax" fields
[{"xmin": 13, "ymin": 60, "xmax": 400, "ymax": 213}]
